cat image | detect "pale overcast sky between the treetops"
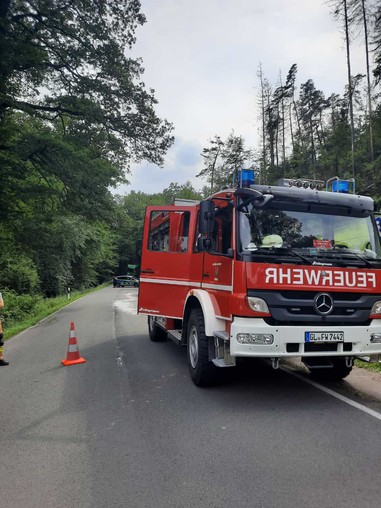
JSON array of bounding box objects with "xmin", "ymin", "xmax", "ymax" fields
[{"xmin": 117, "ymin": 0, "xmax": 365, "ymax": 194}]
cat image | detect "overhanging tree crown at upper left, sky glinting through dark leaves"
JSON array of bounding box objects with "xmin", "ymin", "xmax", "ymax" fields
[{"xmin": 0, "ymin": 0, "xmax": 173, "ymax": 169}]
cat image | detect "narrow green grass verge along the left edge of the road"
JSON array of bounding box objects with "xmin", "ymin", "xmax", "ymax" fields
[{"xmin": 3, "ymin": 284, "xmax": 109, "ymax": 340}]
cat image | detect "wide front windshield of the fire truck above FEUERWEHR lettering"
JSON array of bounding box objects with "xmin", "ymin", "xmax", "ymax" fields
[{"xmin": 238, "ymin": 200, "xmax": 381, "ymax": 264}]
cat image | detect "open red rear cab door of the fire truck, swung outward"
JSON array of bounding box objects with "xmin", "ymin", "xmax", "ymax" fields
[{"xmin": 138, "ymin": 206, "xmax": 202, "ymax": 319}]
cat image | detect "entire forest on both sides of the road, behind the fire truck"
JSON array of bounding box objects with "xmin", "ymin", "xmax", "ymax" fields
[{"xmin": 0, "ymin": 0, "xmax": 381, "ymax": 326}]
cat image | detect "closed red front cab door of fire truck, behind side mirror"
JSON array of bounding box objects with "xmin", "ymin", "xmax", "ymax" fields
[{"xmin": 202, "ymin": 201, "xmax": 234, "ymax": 319}]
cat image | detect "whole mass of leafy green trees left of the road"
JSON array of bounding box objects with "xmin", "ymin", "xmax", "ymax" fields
[{"xmin": 0, "ymin": 0, "xmax": 173, "ymax": 299}]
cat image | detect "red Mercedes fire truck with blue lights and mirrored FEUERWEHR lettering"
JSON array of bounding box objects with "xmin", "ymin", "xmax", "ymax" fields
[{"xmin": 138, "ymin": 175, "xmax": 381, "ymax": 386}]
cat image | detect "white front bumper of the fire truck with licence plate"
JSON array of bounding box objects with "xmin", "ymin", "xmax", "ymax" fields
[{"xmin": 230, "ymin": 317, "xmax": 381, "ymax": 358}]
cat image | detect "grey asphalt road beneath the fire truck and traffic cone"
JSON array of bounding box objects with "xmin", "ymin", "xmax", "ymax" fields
[{"xmin": 0, "ymin": 287, "xmax": 381, "ymax": 508}]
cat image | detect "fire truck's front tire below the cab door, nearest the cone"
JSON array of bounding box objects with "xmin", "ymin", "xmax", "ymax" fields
[{"xmin": 187, "ymin": 308, "xmax": 221, "ymax": 386}]
